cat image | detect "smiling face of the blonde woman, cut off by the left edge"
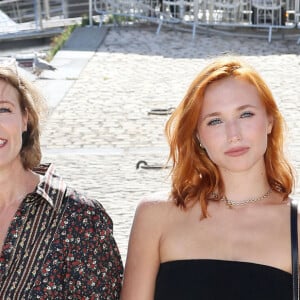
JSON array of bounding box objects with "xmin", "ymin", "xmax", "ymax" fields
[{"xmin": 0, "ymin": 80, "xmax": 28, "ymax": 171}]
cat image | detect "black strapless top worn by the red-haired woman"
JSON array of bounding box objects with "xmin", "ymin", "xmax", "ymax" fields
[{"xmin": 154, "ymin": 259, "xmax": 292, "ymax": 300}]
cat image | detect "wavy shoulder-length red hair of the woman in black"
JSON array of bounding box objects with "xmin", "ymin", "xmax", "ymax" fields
[{"xmin": 165, "ymin": 57, "xmax": 294, "ymax": 217}]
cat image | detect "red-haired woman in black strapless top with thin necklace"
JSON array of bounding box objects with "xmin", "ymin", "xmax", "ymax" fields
[{"xmin": 121, "ymin": 57, "xmax": 294, "ymax": 300}]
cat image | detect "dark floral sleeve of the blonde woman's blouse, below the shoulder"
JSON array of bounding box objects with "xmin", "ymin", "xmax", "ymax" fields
[{"xmin": 65, "ymin": 191, "xmax": 123, "ymax": 300}]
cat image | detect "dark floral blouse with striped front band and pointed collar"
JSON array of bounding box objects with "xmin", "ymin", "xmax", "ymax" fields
[{"xmin": 0, "ymin": 165, "xmax": 123, "ymax": 300}]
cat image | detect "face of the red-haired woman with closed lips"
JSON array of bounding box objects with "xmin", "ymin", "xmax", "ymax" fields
[{"xmin": 198, "ymin": 78, "xmax": 273, "ymax": 173}]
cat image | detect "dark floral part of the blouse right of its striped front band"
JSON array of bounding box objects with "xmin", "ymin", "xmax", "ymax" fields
[{"xmin": 29, "ymin": 192, "xmax": 123, "ymax": 300}]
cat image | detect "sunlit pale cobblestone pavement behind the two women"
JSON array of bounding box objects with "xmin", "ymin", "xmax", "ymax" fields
[{"xmin": 42, "ymin": 26, "xmax": 300, "ymax": 261}]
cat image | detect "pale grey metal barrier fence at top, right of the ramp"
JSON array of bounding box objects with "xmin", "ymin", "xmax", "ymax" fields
[{"xmin": 89, "ymin": 0, "xmax": 300, "ymax": 42}]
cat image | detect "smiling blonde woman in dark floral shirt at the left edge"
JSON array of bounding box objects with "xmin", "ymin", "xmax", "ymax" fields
[{"xmin": 0, "ymin": 61, "xmax": 123, "ymax": 299}]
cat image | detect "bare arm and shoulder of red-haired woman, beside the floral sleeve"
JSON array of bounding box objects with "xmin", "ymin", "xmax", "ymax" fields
[{"xmin": 121, "ymin": 194, "xmax": 173, "ymax": 300}]
